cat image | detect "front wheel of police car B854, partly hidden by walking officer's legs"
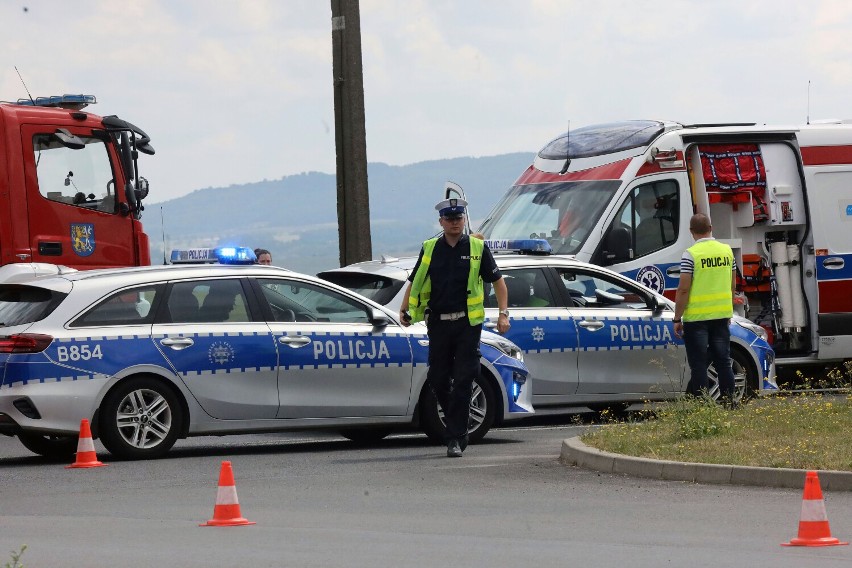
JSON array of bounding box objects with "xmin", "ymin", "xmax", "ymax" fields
[{"xmin": 420, "ymin": 375, "xmax": 497, "ymax": 444}]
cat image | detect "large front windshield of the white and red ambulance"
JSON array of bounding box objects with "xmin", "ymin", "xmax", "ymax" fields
[{"xmin": 479, "ymin": 180, "xmax": 621, "ymax": 254}]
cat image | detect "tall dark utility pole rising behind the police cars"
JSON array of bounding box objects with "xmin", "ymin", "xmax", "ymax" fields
[{"xmin": 331, "ymin": 0, "xmax": 373, "ymax": 266}]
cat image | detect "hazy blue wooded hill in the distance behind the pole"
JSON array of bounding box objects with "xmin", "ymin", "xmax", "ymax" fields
[{"xmin": 142, "ymin": 152, "xmax": 534, "ymax": 274}]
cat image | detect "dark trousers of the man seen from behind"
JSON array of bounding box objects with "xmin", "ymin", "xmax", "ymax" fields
[{"xmin": 683, "ymin": 319, "xmax": 734, "ymax": 398}]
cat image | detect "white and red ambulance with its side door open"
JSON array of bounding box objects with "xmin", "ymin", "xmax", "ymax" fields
[{"xmin": 479, "ymin": 120, "xmax": 852, "ymax": 365}]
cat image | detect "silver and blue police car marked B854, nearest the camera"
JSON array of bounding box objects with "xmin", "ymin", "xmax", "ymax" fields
[{"xmin": 0, "ymin": 248, "xmax": 532, "ymax": 459}]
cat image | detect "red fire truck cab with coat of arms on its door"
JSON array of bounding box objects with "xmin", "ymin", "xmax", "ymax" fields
[{"xmin": 0, "ymin": 95, "xmax": 154, "ymax": 269}]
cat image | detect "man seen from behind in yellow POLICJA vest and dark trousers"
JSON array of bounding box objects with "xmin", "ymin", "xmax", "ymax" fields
[{"xmin": 674, "ymin": 213, "xmax": 736, "ymax": 403}]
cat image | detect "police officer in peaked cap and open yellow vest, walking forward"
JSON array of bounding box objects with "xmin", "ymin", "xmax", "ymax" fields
[{"xmin": 400, "ymin": 199, "xmax": 509, "ymax": 458}]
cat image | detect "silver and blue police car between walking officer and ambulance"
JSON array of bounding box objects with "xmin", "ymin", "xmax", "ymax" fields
[{"xmin": 319, "ymin": 239, "xmax": 778, "ymax": 414}]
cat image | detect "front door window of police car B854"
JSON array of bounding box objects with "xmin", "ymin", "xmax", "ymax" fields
[{"xmin": 258, "ymin": 278, "xmax": 370, "ymax": 323}]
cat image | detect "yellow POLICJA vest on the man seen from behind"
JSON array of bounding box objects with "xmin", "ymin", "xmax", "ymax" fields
[{"xmin": 683, "ymin": 240, "xmax": 734, "ymax": 321}]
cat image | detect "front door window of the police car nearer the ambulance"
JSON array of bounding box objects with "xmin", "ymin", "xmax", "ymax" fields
[{"xmin": 557, "ymin": 268, "xmax": 647, "ymax": 309}]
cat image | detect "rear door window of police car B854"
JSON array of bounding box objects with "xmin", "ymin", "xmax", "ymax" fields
[{"xmin": 166, "ymin": 278, "xmax": 251, "ymax": 323}]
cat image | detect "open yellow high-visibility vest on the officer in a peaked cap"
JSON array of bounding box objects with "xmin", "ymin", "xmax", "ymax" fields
[{"xmin": 408, "ymin": 237, "xmax": 485, "ymax": 325}]
